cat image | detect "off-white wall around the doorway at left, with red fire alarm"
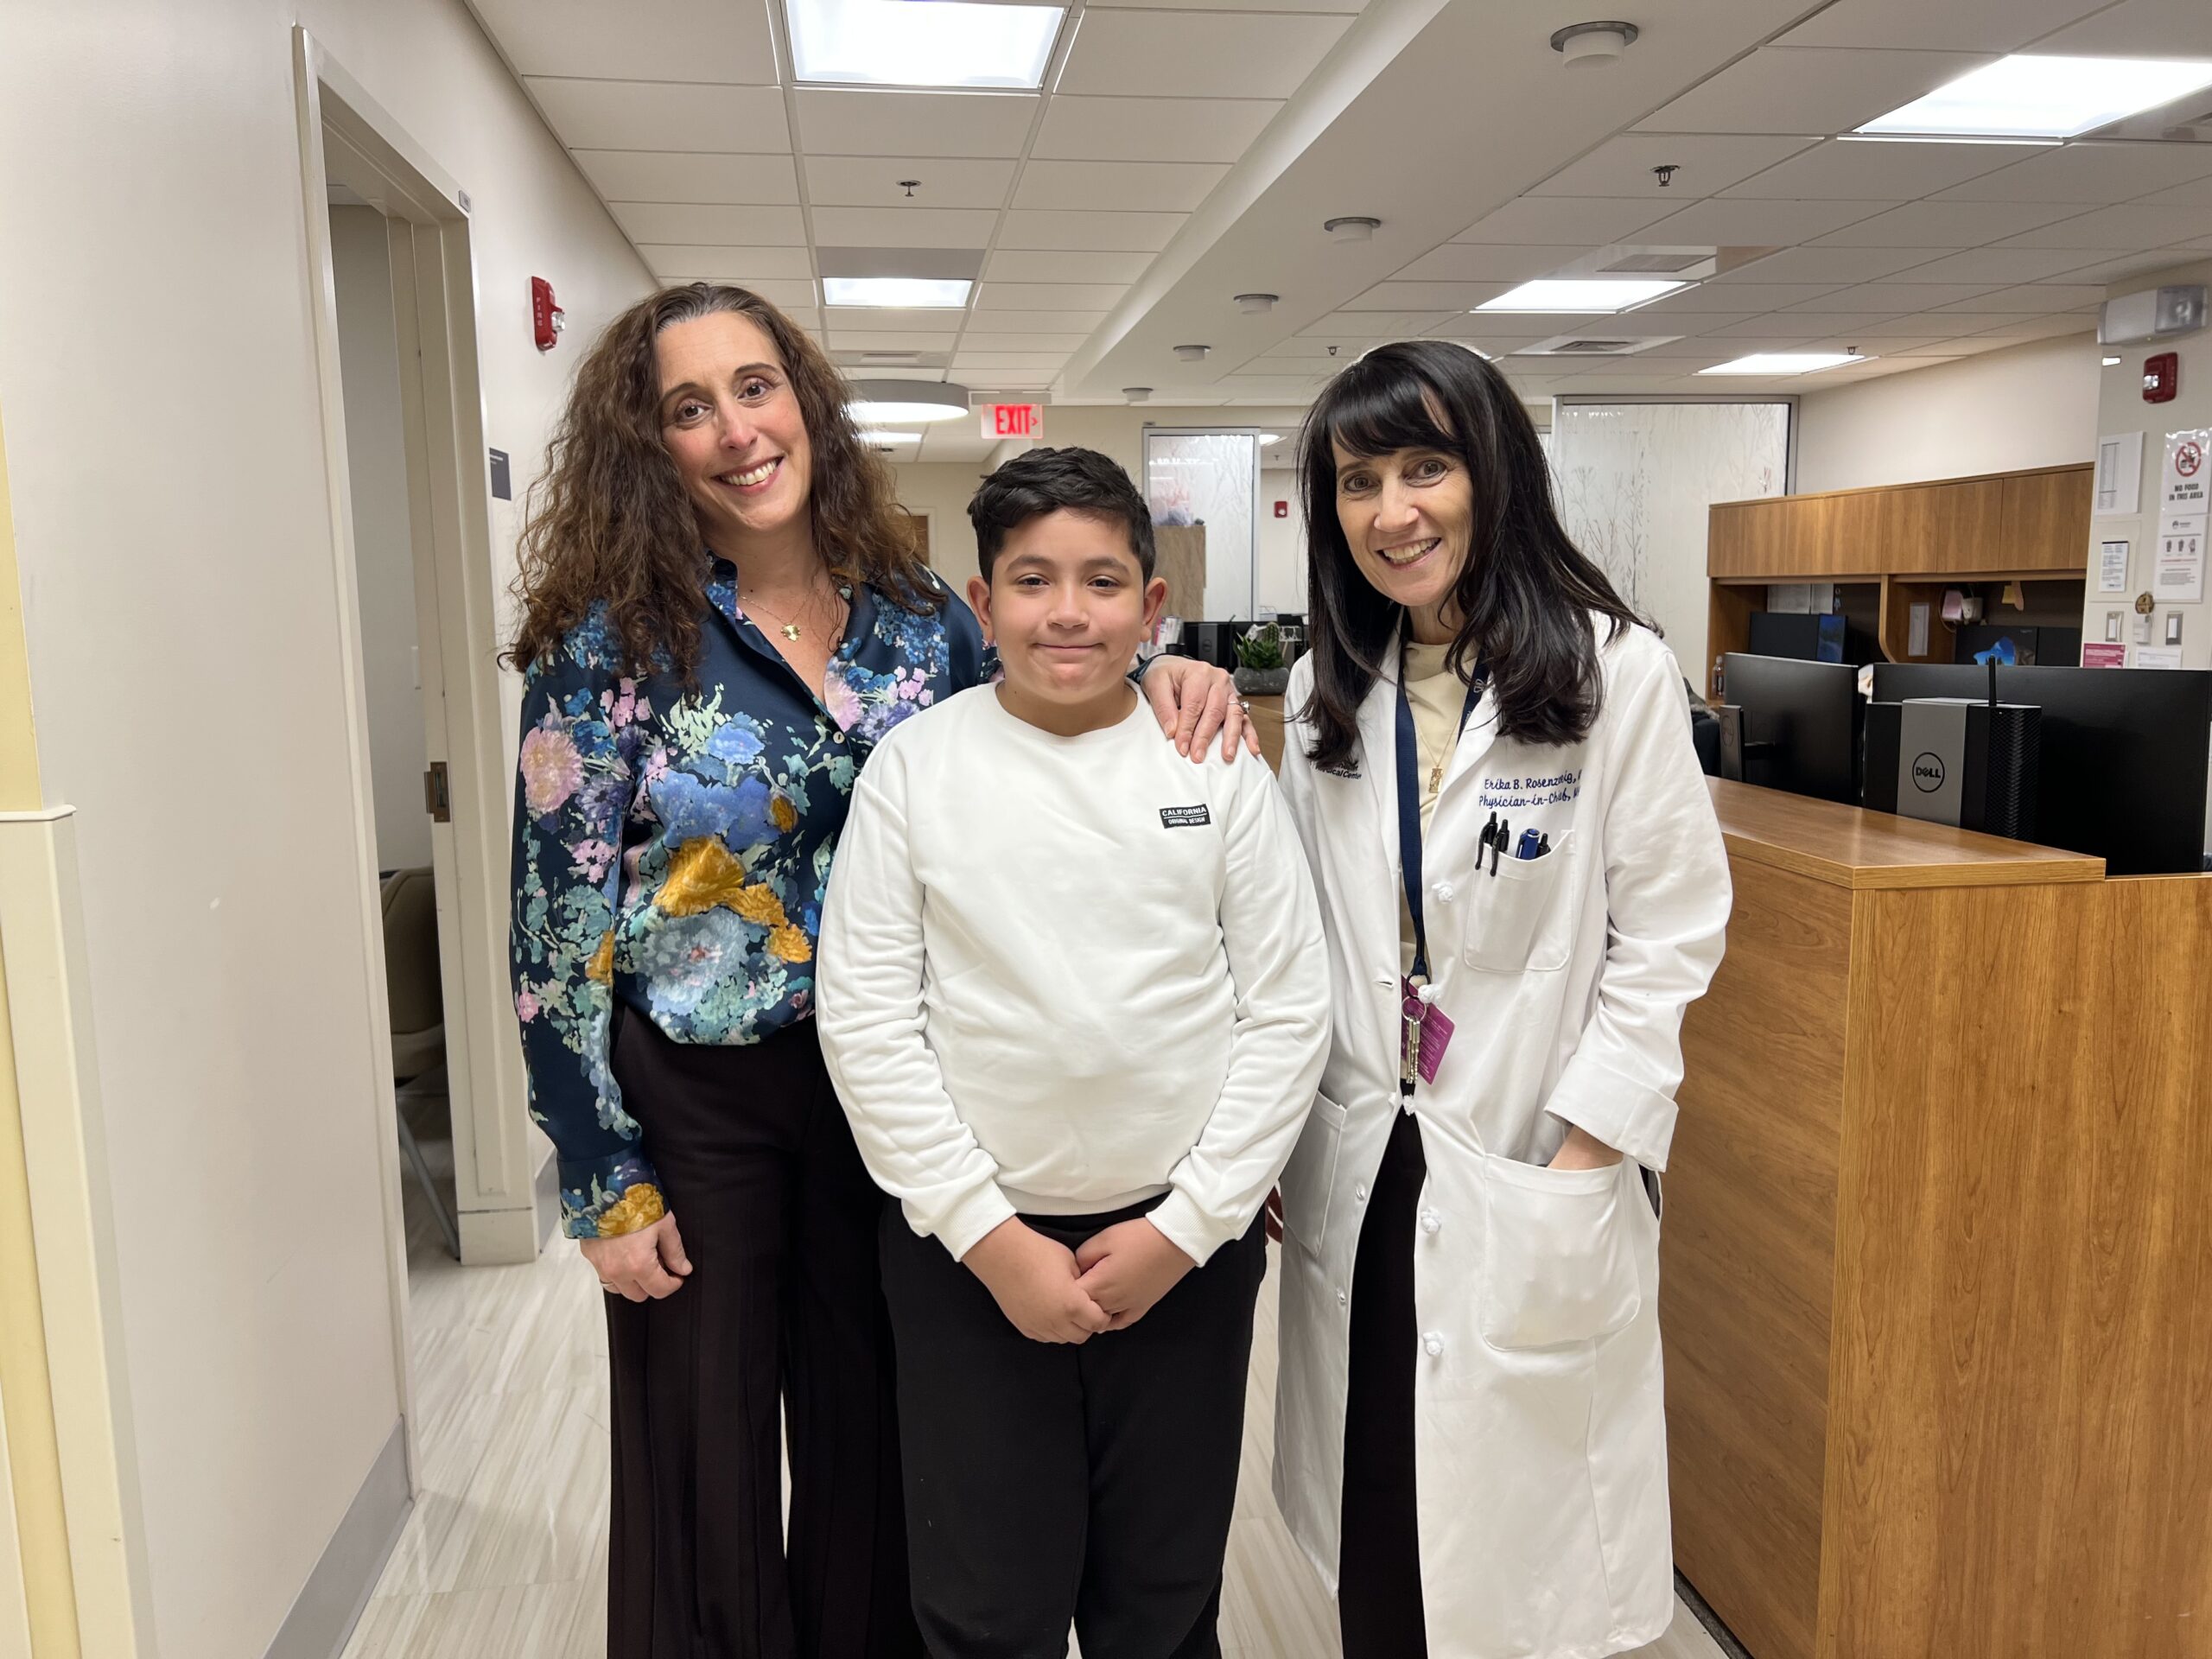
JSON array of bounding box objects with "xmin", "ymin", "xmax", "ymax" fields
[{"xmin": 0, "ymin": 0, "xmax": 651, "ymax": 1659}]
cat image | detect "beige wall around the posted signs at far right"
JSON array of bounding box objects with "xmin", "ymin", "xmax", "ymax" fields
[{"xmin": 2082, "ymin": 259, "xmax": 2212, "ymax": 677}]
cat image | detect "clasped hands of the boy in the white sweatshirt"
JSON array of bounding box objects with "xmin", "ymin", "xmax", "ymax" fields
[{"xmin": 963, "ymin": 1217, "xmax": 1197, "ymax": 1343}]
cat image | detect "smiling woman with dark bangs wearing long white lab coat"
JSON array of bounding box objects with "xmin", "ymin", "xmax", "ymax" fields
[{"xmin": 1274, "ymin": 340, "xmax": 1730, "ymax": 1659}]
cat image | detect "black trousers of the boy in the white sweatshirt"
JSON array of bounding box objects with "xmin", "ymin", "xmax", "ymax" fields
[{"xmin": 882, "ymin": 1204, "xmax": 1268, "ymax": 1659}]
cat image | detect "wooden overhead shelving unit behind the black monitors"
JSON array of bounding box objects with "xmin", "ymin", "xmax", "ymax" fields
[{"xmin": 1706, "ymin": 465, "xmax": 2094, "ymax": 677}]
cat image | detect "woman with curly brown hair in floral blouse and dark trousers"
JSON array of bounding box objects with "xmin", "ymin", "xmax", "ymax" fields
[{"xmin": 511, "ymin": 283, "xmax": 1243, "ymax": 1659}]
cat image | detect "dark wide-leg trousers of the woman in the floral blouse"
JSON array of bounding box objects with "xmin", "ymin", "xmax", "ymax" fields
[{"xmin": 606, "ymin": 1011, "xmax": 923, "ymax": 1659}]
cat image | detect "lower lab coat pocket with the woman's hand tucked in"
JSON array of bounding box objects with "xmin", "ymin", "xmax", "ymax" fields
[{"xmin": 1480, "ymin": 1157, "xmax": 1643, "ymax": 1350}]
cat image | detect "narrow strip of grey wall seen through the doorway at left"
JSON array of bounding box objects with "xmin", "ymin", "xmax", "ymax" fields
[{"xmin": 329, "ymin": 208, "xmax": 429, "ymax": 869}]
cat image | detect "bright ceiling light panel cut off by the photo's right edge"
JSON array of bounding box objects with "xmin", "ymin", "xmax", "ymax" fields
[{"xmin": 1858, "ymin": 55, "xmax": 2212, "ymax": 139}]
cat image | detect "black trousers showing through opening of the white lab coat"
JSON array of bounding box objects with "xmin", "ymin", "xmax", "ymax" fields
[{"xmin": 1336, "ymin": 1113, "xmax": 1429, "ymax": 1659}]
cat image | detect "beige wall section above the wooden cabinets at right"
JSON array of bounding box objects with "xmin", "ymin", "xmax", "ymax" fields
[{"xmin": 1796, "ymin": 334, "xmax": 2099, "ymax": 495}]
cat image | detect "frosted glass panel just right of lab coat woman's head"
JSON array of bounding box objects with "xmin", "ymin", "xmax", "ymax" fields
[{"xmin": 1551, "ymin": 403, "xmax": 1789, "ymax": 690}]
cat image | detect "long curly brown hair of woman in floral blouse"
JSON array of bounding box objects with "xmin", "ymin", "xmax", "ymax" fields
[{"xmin": 505, "ymin": 283, "xmax": 944, "ymax": 688}]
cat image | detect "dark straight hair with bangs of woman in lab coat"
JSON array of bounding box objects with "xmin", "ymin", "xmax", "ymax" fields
[{"xmin": 1299, "ymin": 340, "xmax": 1642, "ymax": 767}]
